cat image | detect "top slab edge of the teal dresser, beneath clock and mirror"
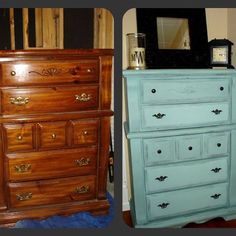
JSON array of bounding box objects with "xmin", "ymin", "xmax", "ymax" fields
[{"xmin": 123, "ymin": 69, "xmax": 236, "ymax": 78}]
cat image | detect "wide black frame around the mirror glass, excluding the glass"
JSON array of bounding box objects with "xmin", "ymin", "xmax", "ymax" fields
[{"xmin": 136, "ymin": 8, "xmax": 209, "ymax": 69}]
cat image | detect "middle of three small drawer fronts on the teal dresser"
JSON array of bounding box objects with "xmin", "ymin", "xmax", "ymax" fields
[{"xmin": 178, "ymin": 136, "xmax": 202, "ymax": 159}]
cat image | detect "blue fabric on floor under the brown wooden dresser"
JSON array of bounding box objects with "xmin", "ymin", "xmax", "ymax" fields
[{"xmin": 14, "ymin": 193, "xmax": 114, "ymax": 229}]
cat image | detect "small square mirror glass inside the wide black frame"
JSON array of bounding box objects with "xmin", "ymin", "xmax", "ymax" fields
[{"xmin": 157, "ymin": 17, "xmax": 190, "ymax": 50}]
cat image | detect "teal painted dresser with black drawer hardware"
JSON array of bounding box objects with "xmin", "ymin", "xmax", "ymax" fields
[{"xmin": 123, "ymin": 69, "xmax": 236, "ymax": 228}]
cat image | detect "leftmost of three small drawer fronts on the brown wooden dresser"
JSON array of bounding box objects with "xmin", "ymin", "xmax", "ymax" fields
[{"xmin": 3, "ymin": 124, "xmax": 34, "ymax": 152}]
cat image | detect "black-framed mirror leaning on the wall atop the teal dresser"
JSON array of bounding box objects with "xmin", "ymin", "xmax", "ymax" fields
[{"xmin": 136, "ymin": 8, "xmax": 209, "ymax": 69}]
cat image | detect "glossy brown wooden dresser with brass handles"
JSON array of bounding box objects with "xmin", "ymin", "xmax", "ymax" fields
[{"xmin": 0, "ymin": 49, "xmax": 113, "ymax": 224}]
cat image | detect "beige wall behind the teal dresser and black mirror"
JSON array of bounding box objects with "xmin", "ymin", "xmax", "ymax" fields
[{"xmin": 122, "ymin": 8, "xmax": 236, "ymax": 203}]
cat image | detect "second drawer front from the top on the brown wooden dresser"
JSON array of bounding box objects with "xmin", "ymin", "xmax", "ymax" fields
[{"xmin": 2, "ymin": 86, "xmax": 99, "ymax": 114}]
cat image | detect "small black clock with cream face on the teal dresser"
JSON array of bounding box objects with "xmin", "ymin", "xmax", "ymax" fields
[{"xmin": 209, "ymin": 39, "xmax": 234, "ymax": 68}]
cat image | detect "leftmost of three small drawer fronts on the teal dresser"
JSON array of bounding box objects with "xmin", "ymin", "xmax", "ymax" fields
[{"xmin": 143, "ymin": 139, "xmax": 175, "ymax": 165}]
